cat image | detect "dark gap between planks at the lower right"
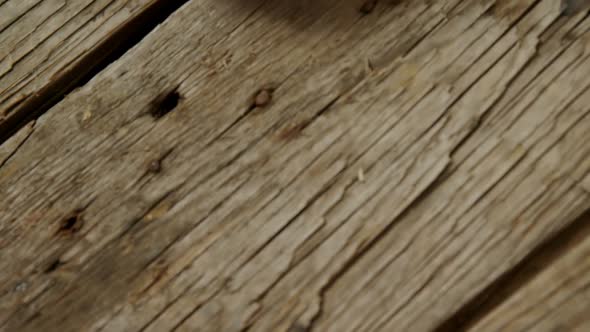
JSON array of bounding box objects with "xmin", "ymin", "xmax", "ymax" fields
[{"xmin": 434, "ymin": 209, "xmax": 590, "ymax": 332}]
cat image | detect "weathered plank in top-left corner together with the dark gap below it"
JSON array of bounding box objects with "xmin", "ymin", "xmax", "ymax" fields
[{"xmin": 0, "ymin": 0, "xmax": 183, "ymax": 139}]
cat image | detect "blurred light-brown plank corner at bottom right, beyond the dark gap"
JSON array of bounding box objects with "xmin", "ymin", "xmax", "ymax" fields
[{"xmin": 470, "ymin": 215, "xmax": 590, "ymax": 332}]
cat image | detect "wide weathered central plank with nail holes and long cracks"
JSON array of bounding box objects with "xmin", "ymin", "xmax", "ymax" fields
[{"xmin": 0, "ymin": 0, "xmax": 590, "ymax": 331}]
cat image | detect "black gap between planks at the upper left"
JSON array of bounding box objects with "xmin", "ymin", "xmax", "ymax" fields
[{"xmin": 0, "ymin": 0, "xmax": 188, "ymax": 144}]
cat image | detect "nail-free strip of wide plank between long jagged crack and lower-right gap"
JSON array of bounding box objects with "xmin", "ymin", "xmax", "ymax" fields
[{"xmin": 308, "ymin": 10, "xmax": 590, "ymax": 331}]
